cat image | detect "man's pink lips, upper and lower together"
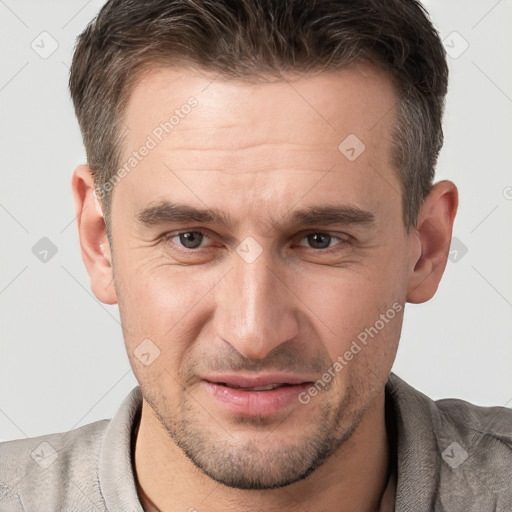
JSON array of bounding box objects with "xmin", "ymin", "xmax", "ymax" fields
[{"xmin": 201, "ymin": 373, "xmax": 312, "ymax": 417}]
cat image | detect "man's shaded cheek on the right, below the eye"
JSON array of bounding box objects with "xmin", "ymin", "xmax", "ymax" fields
[{"xmin": 295, "ymin": 251, "xmax": 407, "ymax": 367}]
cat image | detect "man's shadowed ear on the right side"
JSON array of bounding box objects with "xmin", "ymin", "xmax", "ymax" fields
[{"xmin": 407, "ymin": 181, "xmax": 458, "ymax": 304}]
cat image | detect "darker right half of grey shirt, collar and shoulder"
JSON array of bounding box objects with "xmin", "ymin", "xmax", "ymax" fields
[{"xmin": 387, "ymin": 374, "xmax": 512, "ymax": 512}]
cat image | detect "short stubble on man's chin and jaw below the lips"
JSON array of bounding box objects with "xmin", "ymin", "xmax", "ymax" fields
[{"xmin": 145, "ymin": 387, "xmax": 371, "ymax": 490}]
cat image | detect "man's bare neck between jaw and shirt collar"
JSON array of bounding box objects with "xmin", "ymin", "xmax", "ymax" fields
[{"xmin": 135, "ymin": 392, "xmax": 394, "ymax": 512}]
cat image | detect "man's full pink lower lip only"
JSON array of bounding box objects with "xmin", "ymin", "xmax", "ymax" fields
[{"xmin": 203, "ymin": 381, "xmax": 311, "ymax": 416}]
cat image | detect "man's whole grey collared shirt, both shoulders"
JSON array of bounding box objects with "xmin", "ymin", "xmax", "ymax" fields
[{"xmin": 0, "ymin": 373, "xmax": 512, "ymax": 512}]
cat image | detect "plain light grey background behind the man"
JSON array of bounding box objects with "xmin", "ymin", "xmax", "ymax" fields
[{"xmin": 0, "ymin": 0, "xmax": 512, "ymax": 440}]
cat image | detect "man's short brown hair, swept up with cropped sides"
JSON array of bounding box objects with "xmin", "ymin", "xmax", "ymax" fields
[{"xmin": 69, "ymin": 0, "xmax": 448, "ymax": 229}]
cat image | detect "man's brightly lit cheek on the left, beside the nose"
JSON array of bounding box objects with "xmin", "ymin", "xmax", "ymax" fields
[{"xmin": 119, "ymin": 270, "xmax": 216, "ymax": 398}]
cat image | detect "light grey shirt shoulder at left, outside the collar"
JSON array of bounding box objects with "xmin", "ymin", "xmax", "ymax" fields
[{"xmin": 0, "ymin": 420, "xmax": 110, "ymax": 512}]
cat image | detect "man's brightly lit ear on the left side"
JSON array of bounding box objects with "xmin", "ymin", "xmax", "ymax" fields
[{"xmin": 71, "ymin": 165, "xmax": 117, "ymax": 304}]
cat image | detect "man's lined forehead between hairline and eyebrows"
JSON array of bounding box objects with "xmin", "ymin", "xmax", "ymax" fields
[{"xmin": 116, "ymin": 64, "xmax": 400, "ymax": 224}]
